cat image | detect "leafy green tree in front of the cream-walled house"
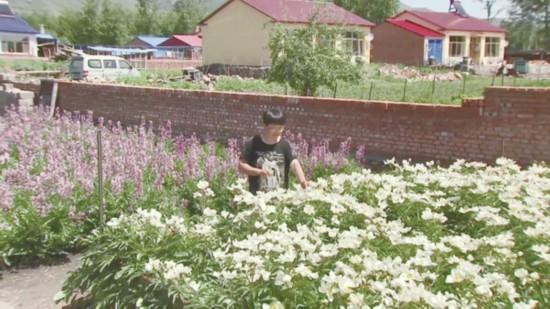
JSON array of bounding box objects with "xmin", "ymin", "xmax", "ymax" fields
[{"xmin": 269, "ymin": 23, "xmax": 361, "ymax": 96}]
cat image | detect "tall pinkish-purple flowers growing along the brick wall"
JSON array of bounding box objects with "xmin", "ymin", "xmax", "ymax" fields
[{"xmin": 0, "ymin": 107, "xmax": 363, "ymax": 269}]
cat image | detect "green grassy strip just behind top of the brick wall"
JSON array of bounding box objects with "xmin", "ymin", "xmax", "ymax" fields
[{"xmin": 119, "ymin": 65, "xmax": 550, "ymax": 104}]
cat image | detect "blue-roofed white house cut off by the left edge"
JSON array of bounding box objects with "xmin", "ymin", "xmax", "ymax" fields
[{"xmin": 0, "ymin": 0, "xmax": 39, "ymax": 57}]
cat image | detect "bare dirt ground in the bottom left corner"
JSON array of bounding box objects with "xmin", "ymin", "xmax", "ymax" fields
[{"xmin": 0, "ymin": 255, "xmax": 81, "ymax": 309}]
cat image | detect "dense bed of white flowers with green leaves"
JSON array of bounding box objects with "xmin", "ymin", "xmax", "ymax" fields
[{"xmin": 59, "ymin": 159, "xmax": 550, "ymax": 308}]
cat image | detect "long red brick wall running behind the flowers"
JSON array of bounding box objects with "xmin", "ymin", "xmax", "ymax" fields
[{"xmin": 52, "ymin": 82, "xmax": 550, "ymax": 164}]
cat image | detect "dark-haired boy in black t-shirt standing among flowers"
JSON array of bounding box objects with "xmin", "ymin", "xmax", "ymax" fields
[{"xmin": 239, "ymin": 109, "xmax": 308, "ymax": 194}]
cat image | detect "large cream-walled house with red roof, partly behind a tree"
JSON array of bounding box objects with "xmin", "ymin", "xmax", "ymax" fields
[{"xmin": 200, "ymin": 0, "xmax": 374, "ymax": 66}]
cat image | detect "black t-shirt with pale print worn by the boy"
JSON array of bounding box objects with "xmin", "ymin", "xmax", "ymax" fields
[{"xmin": 241, "ymin": 135, "xmax": 295, "ymax": 194}]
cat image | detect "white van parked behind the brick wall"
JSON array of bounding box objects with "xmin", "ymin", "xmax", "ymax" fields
[{"xmin": 69, "ymin": 55, "xmax": 140, "ymax": 81}]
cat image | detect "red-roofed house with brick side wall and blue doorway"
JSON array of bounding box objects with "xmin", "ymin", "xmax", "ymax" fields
[{"xmin": 372, "ymin": 10, "xmax": 507, "ymax": 66}]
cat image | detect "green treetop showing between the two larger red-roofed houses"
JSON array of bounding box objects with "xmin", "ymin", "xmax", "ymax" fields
[{"xmin": 333, "ymin": 0, "xmax": 400, "ymax": 24}]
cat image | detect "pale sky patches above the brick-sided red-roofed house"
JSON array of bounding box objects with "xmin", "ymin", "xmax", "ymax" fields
[{"xmin": 401, "ymin": 0, "xmax": 511, "ymax": 18}]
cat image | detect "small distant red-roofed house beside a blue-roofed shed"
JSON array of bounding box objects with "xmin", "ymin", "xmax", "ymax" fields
[{"xmin": 157, "ymin": 34, "xmax": 202, "ymax": 60}]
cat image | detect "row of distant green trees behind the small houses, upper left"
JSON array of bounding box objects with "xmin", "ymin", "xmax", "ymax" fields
[{"xmin": 23, "ymin": 0, "xmax": 206, "ymax": 45}]
